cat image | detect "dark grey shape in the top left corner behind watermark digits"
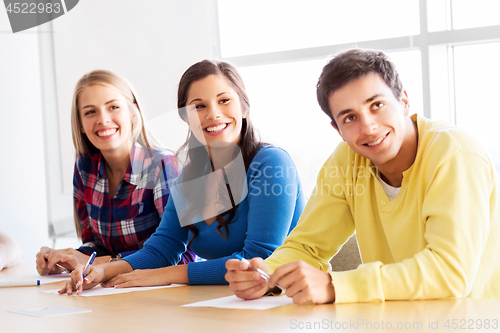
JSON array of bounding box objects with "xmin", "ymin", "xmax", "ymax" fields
[{"xmin": 4, "ymin": 0, "xmax": 79, "ymax": 33}]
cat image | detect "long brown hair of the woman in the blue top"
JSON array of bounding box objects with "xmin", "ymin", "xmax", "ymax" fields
[{"xmin": 176, "ymin": 60, "xmax": 263, "ymax": 247}]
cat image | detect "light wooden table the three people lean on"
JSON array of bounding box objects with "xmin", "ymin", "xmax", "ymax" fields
[{"xmin": 0, "ymin": 264, "xmax": 500, "ymax": 333}]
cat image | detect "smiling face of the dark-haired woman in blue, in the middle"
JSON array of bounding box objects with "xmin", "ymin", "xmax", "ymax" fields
[{"xmin": 186, "ymin": 75, "xmax": 244, "ymax": 147}]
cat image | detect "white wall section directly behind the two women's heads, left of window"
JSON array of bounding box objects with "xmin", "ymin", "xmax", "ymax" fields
[{"xmin": 54, "ymin": 0, "xmax": 217, "ymax": 193}]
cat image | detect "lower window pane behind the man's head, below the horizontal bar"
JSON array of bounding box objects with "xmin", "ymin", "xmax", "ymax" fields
[{"xmin": 239, "ymin": 51, "xmax": 422, "ymax": 195}]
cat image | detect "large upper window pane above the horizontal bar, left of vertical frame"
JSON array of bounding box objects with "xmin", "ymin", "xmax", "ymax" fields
[{"xmin": 219, "ymin": 0, "xmax": 420, "ymax": 57}]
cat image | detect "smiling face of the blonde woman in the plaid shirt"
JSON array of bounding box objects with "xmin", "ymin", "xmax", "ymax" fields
[{"xmin": 78, "ymin": 85, "xmax": 133, "ymax": 154}]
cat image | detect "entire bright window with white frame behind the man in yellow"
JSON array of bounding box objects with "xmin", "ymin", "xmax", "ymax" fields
[{"xmin": 217, "ymin": 0, "xmax": 500, "ymax": 189}]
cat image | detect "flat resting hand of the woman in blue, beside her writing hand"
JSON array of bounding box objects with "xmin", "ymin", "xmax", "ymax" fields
[{"xmin": 103, "ymin": 265, "xmax": 176, "ymax": 288}]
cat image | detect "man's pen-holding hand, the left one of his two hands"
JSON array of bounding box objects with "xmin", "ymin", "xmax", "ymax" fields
[{"xmin": 225, "ymin": 258, "xmax": 269, "ymax": 299}]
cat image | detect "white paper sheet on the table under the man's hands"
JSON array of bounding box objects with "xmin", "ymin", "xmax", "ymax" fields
[{"xmin": 183, "ymin": 296, "xmax": 293, "ymax": 310}]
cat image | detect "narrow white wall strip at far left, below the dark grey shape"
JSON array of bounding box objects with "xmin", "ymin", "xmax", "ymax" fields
[{"xmin": 0, "ymin": 10, "xmax": 48, "ymax": 261}]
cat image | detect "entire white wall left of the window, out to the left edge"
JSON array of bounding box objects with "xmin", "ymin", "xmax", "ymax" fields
[{"xmin": 0, "ymin": 0, "xmax": 215, "ymax": 261}]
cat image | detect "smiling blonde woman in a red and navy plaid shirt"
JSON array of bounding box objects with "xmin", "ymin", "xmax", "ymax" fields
[{"xmin": 36, "ymin": 70, "xmax": 193, "ymax": 275}]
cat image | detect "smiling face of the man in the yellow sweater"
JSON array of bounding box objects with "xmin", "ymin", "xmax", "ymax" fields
[{"xmin": 328, "ymin": 73, "xmax": 416, "ymax": 173}]
